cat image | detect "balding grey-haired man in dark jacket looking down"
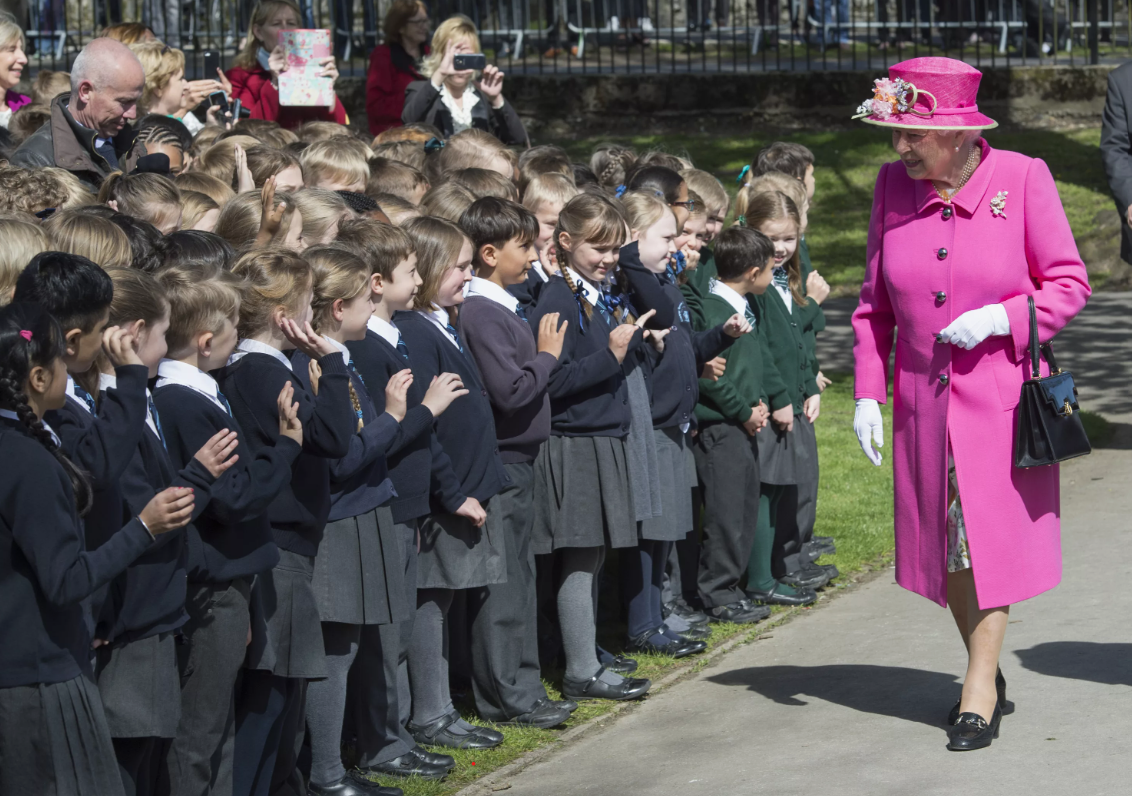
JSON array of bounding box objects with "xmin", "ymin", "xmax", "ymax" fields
[{"xmin": 11, "ymin": 38, "xmax": 145, "ymax": 192}]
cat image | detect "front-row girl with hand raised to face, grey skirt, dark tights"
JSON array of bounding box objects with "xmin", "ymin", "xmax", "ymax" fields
[{"xmin": 217, "ymin": 248, "xmax": 357, "ymax": 795}]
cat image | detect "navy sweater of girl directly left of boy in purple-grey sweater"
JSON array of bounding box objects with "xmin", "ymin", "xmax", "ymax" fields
[{"xmin": 394, "ymin": 313, "xmax": 511, "ymax": 512}]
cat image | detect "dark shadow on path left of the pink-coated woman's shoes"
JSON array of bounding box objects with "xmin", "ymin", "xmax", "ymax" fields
[{"xmin": 708, "ymin": 664, "xmax": 961, "ymax": 728}]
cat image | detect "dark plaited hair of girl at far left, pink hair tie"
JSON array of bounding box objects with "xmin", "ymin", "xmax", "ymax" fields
[{"xmin": 0, "ymin": 302, "xmax": 93, "ymax": 515}]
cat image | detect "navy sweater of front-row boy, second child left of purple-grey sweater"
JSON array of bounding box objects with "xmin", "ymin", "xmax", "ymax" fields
[{"xmin": 340, "ymin": 329, "xmax": 464, "ymax": 522}]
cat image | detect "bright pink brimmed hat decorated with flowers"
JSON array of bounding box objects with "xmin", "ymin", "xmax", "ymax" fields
[{"xmin": 854, "ymin": 58, "xmax": 998, "ymax": 130}]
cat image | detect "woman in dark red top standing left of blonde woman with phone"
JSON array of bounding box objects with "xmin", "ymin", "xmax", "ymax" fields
[{"xmin": 366, "ymin": 0, "xmax": 430, "ymax": 136}]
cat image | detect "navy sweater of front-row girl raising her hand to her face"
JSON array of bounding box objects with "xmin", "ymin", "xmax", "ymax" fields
[{"xmin": 217, "ymin": 352, "xmax": 354, "ymax": 556}]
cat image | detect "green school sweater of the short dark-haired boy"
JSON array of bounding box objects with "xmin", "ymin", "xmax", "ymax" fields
[{"xmin": 693, "ymin": 292, "xmax": 790, "ymax": 425}]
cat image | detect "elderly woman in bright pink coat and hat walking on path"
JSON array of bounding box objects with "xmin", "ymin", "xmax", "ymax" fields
[{"xmin": 852, "ymin": 58, "xmax": 1090, "ymax": 751}]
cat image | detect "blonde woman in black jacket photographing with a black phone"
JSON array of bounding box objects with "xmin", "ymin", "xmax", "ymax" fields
[{"xmin": 401, "ymin": 14, "xmax": 528, "ymax": 145}]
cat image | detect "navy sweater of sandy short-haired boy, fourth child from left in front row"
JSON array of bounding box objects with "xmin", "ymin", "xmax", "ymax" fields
[{"xmin": 153, "ymin": 384, "xmax": 302, "ymax": 583}]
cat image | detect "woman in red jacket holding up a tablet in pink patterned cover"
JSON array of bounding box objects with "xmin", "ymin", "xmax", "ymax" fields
[{"xmin": 220, "ymin": 0, "xmax": 348, "ymax": 129}]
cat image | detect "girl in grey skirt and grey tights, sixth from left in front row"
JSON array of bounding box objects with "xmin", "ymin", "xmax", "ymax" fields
[{"xmin": 291, "ymin": 246, "xmax": 414, "ymax": 796}]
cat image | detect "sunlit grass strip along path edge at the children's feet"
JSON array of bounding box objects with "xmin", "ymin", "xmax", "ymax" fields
[{"xmin": 366, "ymin": 375, "xmax": 892, "ymax": 796}]
